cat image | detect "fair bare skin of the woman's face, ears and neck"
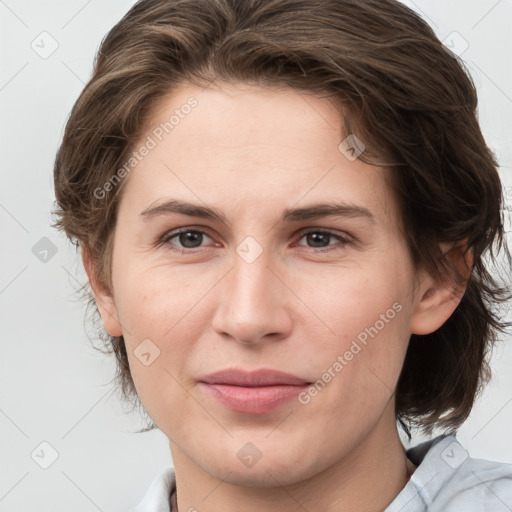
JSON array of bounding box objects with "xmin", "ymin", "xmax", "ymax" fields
[{"xmin": 83, "ymin": 83, "xmax": 466, "ymax": 512}]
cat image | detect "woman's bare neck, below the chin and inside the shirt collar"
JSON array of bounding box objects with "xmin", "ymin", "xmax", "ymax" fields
[{"xmin": 171, "ymin": 406, "xmax": 415, "ymax": 512}]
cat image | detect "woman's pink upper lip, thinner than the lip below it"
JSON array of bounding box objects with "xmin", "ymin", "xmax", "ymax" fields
[{"xmin": 199, "ymin": 368, "xmax": 311, "ymax": 387}]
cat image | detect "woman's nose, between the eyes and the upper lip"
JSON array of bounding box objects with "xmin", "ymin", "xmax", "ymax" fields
[{"xmin": 212, "ymin": 246, "xmax": 293, "ymax": 345}]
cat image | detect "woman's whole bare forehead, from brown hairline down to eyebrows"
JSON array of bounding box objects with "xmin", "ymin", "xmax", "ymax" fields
[{"xmin": 119, "ymin": 83, "xmax": 392, "ymax": 228}]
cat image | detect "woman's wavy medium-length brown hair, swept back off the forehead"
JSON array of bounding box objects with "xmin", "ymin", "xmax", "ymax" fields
[{"xmin": 54, "ymin": 0, "xmax": 510, "ymax": 436}]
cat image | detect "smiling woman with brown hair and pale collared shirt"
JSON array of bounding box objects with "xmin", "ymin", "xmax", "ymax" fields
[{"xmin": 54, "ymin": 0, "xmax": 512, "ymax": 512}]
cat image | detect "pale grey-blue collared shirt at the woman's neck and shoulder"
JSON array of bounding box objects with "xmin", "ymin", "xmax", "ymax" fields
[{"xmin": 131, "ymin": 434, "xmax": 512, "ymax": 512}]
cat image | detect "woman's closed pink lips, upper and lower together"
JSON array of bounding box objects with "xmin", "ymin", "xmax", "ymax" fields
[{"xmin": 199, "ymin": 368, "xmax": 311, "ymax": 414}]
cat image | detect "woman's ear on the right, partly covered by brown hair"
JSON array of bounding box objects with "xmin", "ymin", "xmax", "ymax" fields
[{"xmin": 410, "ymin": 244, "xmax": 473, "ymax": 334}]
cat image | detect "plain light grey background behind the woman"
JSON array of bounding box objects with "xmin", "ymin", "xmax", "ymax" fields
[{"xmin": 0, "ymin": 0, "xmax": 512, "ymax": 512}]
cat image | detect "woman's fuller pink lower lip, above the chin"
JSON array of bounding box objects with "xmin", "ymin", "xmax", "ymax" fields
[{"xmin": 200, "ymin": 382, "xmax": 309, "ymax": 414}]
